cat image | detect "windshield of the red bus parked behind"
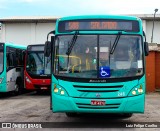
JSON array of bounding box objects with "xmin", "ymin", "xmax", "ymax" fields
[{"xmin": 26, "ymin": 52, "xmax": 50, "ymax": 75}]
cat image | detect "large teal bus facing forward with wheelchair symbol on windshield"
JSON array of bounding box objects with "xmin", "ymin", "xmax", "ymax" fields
[{"xmin": 44, "ymin": 15, "xmax": 149, "ymax": 117}]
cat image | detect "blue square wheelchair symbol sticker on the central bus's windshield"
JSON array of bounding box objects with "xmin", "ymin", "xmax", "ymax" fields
[{"xmin": 99, "ymin": 66, "xmax": 110, "ymax": 78}]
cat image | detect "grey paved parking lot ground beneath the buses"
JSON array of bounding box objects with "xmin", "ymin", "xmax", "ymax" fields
[{"xmin": 0, "ymin": 92, "xmax": 160, "ymax": 127}]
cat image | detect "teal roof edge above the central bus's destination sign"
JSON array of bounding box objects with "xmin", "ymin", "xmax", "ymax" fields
[{"xmin": 58, "ymin": 15, "xmax": 140, "ymax": 21}]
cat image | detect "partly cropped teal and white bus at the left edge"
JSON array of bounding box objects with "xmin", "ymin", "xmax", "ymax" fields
[{"xmin": 0, "ymin": 43, "xmax": 26, "ymax": 95}]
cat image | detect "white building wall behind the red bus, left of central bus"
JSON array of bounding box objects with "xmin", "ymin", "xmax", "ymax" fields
[{"xmin": 0, "ymin": 17, "xmax": 57, "ymax": 45}]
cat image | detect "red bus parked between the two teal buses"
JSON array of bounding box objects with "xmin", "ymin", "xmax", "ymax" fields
[{"xmin": 24, "ymin": 44, "xmax": 51, "ymax": 92}]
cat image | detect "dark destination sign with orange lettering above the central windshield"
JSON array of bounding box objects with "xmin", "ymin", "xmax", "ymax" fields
[{"xmin": 58, "ymin": 20, "xmax": 139, "ymax": 32}]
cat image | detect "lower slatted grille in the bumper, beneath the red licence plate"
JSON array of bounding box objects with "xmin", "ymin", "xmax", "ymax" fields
[{"xmin": 76, "ymin": 103, "xmax": 120, "ymax": 109}]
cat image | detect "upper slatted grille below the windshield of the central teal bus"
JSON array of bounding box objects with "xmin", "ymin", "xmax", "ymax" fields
[{"xmin": 73, "ymin": 85, "xmax": 123, "ymax": 92}]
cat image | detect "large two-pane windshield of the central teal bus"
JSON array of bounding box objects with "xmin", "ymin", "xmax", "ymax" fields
[{"xmin": 53, "ymin": 35, "xmax": 143, "ymax": 78}]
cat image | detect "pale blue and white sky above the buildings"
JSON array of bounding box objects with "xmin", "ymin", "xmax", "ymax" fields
[{"xmin": 0, "ymin": 0, "xmax": 160, "ymax": 18}]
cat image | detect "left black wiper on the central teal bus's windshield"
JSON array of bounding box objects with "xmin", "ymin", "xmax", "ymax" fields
[{"xmin": 66, "ymin": 31, "xmax": 79, "ymax": 56}]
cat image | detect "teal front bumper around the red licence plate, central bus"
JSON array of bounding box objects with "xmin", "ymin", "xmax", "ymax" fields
[{"xmin": 52, "ymin": 94, "xmax": 145, "ymax": 113}]
